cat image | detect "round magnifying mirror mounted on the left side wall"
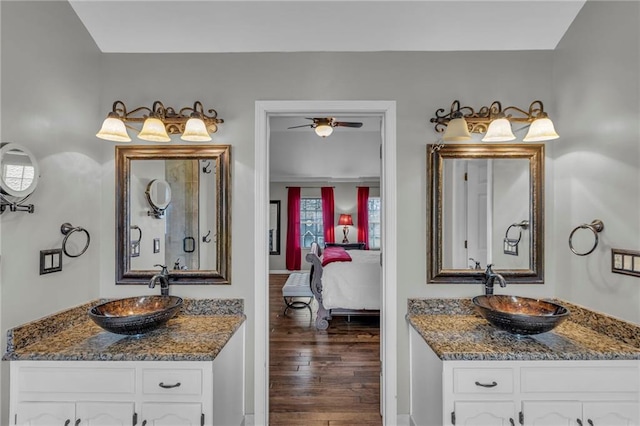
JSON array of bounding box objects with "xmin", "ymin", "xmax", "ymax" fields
[{"xmin": 0, "ymin": 142, "xmax": 40, "ymax": 213}]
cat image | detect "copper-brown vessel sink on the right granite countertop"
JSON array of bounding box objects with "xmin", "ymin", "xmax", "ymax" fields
[{"xmin": 473, "ymin": 295, "xmax": 569, "ymax": 335}]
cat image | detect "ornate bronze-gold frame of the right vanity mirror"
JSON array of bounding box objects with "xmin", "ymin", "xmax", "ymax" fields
[{"xmin": 427, "ymin": 143, "xmax": 544, "ymax": 285}]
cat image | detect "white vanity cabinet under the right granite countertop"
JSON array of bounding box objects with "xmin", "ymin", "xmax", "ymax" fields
[{"xmin": 409, "ymin": 327, "xmax": 640, "ymax": 426}]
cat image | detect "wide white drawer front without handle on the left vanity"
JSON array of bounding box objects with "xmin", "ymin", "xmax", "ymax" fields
[{"xmin": 18, "ymin": 367, "xmax": 136, "ymax": 395}]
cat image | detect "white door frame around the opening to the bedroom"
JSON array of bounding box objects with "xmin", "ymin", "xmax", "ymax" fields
[{"xmin": 253, "ymin": 101, "xmax": 398, "ymax": 425}]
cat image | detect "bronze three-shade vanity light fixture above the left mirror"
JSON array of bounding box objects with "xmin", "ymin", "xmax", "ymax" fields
[{"xmin": 96, "ymin": 101, "xmax": 224, "ymax": 142}]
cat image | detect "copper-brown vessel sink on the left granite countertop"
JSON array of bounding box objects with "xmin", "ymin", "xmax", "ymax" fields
[{"xmin": 88, "ymin": 296, "xmax": 182, "ymax": 335}]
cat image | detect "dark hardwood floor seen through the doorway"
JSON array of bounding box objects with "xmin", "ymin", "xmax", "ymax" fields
[{"xmin": 269, "ymin": 274, "xmax": 382, "ymax": 426}]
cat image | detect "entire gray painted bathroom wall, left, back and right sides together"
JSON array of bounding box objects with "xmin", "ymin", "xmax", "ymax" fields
[{"xmin": 0, "ymin": 2, "xmax": 640, "ymax": 421}]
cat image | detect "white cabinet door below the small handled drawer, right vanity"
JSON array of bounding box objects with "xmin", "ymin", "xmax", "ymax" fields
[{"xmin": 455, "ymin": 401, "xmax": 516, "ymax": 426}]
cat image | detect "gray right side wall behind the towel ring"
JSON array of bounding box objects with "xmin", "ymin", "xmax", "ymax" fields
[{"xmin": 547, "ymin": 1, "xmax": 640, "ymax": 323}]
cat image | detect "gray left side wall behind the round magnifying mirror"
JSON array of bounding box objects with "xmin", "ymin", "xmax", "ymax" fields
[{"xmin": 0, "ymin": 1, "xmax": 102, "ymax": 424}]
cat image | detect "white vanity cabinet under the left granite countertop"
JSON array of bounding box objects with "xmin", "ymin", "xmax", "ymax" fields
[{"xmin": 10, "ymin": 325, "xmax": 245, "ymax": 426}]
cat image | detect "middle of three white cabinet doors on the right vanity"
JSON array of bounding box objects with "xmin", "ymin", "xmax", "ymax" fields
[{"xmin": 522, "ymin": 401, "xmax": 582, "ymax": 426}]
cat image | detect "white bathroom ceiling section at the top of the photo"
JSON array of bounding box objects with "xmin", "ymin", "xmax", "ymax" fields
[{"xmin": 69, "ymin": 0, "xmax": 585, "ymax": 52}]
